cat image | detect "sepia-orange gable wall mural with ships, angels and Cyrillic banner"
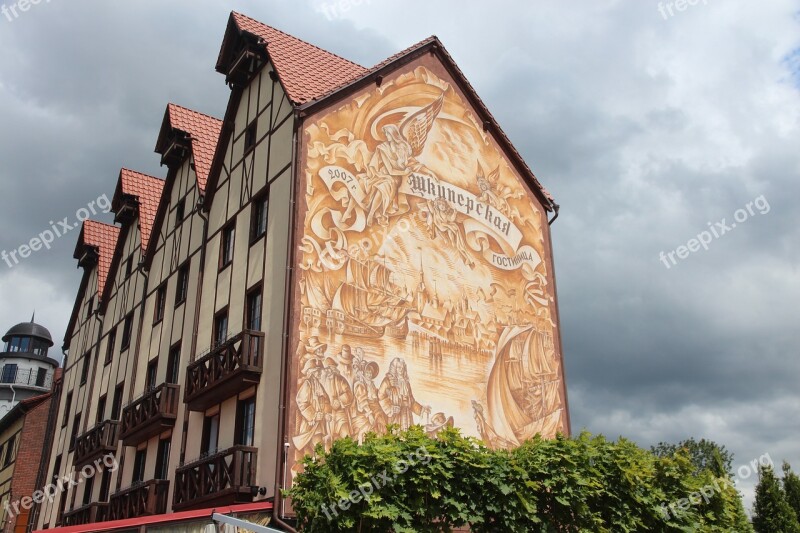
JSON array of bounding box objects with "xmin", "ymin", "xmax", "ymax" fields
[{"xmin": 287, "ymin": 58, "xmax": 568, "ymax": 478}]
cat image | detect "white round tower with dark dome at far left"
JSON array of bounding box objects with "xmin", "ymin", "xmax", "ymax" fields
[{"xmin": 0, "ymin": 318, "xmax": 58, "ymax": 419}]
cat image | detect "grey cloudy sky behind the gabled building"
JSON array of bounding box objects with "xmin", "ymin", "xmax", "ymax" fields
[{"xmin": 0, "ymin": 0, "xmax": 800, "ymax": 508}]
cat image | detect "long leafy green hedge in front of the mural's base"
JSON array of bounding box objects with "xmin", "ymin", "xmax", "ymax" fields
[{"xmin": 286, "ymin": 427, "xmax": 752, "ymax": 533}]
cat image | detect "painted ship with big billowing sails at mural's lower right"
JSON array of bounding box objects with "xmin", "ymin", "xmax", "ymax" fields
[{"xmin": 478, "ymin": 325, "xmax": 563, "ymax": 447}]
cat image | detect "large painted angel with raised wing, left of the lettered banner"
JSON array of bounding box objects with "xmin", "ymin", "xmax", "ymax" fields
[{"xmin": 361, "ymin": 94, "xmax": 444, "ymax": 226}]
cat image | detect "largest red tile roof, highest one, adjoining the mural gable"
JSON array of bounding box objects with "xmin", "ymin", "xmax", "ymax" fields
[{"xmin": 231, "ymin": 11, "xmax": 367, "ymax": 104}]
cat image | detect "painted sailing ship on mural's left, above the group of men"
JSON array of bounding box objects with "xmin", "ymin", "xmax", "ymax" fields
[{"xmin": 327, "ymin": 258, "xmax": 411, "ymax": 338}]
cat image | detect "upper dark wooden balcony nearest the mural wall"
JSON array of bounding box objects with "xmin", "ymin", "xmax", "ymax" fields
[{"xmin": 183, "ymin": 330, "xmax": 264, "ymax": 411}]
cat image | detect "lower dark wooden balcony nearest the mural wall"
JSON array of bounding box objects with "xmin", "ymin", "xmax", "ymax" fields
[{"xmin": 172, "ymin": 446, "xmax": 258, "ymax": 511}]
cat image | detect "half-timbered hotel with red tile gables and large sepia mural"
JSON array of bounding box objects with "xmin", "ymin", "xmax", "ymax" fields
[{"xmin": 37, "ymin": 13, "xmax": 569, "ymax": 531}]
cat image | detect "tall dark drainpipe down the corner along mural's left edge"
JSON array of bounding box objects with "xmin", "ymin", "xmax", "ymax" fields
[{"xmin": 272, "ymin": 112, "xmax": 300, "ymax": 533}]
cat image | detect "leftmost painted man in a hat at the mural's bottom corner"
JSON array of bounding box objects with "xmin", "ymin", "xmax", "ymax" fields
[{"xmin": 293, "ymin": 358, "xmax": 332, "ymax": 456}]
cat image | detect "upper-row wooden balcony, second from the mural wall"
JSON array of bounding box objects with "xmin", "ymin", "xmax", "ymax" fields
[{"xmin": 120, "ymin": 383, "xmax": 181, "ymax": 446}]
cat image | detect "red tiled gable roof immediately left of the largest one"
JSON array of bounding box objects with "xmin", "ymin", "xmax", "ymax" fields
[{"xmin": 167, "ymin": 104, "xmax": 222, "ymax": 193}]
